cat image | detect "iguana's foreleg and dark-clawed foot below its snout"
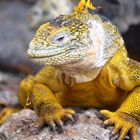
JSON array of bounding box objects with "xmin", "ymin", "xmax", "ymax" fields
[{"xmin": 32, "ymin": 83, "xmax": 75, "ymax": 132}]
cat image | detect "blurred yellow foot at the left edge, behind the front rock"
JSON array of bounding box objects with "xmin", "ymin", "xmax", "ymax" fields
[{"xmin": 0, "ymin": 107, "xmax": 19, "ymax": 125}]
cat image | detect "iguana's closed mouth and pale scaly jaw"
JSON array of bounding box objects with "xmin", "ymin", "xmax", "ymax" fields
[{"xmin": 27, "ymin": 44, "xmax": 86, "ymax": 65}]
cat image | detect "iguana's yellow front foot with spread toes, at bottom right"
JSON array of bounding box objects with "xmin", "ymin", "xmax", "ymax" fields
[{"xmin": 100, "ymin": 110, "xmax": 139, "ymax": 140}]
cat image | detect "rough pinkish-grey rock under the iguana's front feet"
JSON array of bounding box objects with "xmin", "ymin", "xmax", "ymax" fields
[{"xmin": 0, "ymin": 109, "xmax": 136, "ymax": 140}]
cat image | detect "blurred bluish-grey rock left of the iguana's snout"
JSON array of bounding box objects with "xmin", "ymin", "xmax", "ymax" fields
[{"xmin": 0, "ymin": 1, "xmax": 40, "ymax": 73}]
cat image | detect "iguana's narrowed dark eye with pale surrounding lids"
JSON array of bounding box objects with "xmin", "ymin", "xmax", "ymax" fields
[{"xmin": 52, "ymin": 34, "xmax": 69, "ymax": 44}]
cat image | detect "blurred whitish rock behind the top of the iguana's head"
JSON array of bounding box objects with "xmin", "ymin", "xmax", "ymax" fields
[{"xmin": 28, "ymin": 0, "xmax": 74, "ymax": 29}]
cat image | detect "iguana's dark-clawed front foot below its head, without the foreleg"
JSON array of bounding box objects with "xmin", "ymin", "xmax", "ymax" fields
[{"xmin": 37, "ymin": 109, "xmax": 77, "ymax": 133}]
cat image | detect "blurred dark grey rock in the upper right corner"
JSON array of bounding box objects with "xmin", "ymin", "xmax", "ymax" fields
[{"xmin": 92, "ymin": 0, "xmax": 140, "ymax": 32}]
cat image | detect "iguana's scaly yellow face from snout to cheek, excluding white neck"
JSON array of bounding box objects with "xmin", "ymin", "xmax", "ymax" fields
[{"xmin": 28, "ymin": 15, "xmax": 89, "ymax": 65}]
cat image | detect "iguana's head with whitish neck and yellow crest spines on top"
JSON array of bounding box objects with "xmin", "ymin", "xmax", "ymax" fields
[{"xmin": 28, "ymin": 0, "xmax": 121, "ymax": 79}]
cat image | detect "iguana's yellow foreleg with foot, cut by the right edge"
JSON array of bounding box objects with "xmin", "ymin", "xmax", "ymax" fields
[{"xmin": 101, "ymin": 86, "xmax": 140, "ymax": 140}]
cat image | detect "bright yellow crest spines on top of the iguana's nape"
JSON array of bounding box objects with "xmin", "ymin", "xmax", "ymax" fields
[{"xmin": 75, "ymin": 0, "xmax": 96, "ymax": 11}]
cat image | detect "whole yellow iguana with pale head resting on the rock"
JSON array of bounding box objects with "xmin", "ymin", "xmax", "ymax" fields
[{"xmin": 0, "ymin": 0, "xmax": 140, "ymax": 140}]
